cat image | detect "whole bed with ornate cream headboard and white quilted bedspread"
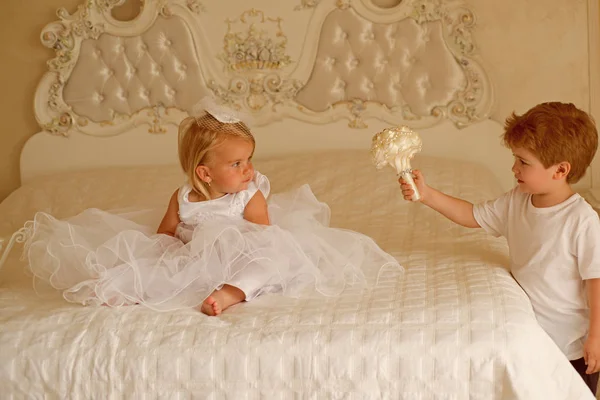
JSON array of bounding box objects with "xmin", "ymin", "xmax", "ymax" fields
[{"xmin": 0, "ymin": 0, "xmax": 593, "ymax": 399}]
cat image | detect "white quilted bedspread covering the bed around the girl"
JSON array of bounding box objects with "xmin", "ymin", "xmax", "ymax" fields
[{"xmin": 0, "ymin": 152, "xmax": 593, "ymax": 400}]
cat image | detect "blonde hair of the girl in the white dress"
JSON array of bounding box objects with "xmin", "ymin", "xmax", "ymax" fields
[{"xmin": 179, "ymin": 113, "xmax": 255, "ymax": 199}]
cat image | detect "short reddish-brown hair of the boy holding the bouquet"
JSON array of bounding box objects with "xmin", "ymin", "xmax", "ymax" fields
[{"xmin": 504, "ymin": 102, "xmax": 598, "ymax": 183}]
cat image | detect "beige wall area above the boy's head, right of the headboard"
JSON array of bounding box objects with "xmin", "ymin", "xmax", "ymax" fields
[{"xmin": 478, "ymin": 0, "xmax": 589, "ymax": 121}]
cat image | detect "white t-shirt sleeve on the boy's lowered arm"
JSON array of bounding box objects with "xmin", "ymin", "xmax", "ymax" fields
[{"xmin": 575, "ymin": 215, "xmax": 600, "ymax": 280}]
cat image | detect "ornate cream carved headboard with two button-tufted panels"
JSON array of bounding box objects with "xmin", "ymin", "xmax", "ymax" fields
[{"xmin": 21, "ymin": 0, "xmax": 511, "ymax": 185}]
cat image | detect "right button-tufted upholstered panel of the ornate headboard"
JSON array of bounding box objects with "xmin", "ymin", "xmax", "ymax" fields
[{"xmin": 296, "ymin": 9, "xmax": 467, "ymax": 115}]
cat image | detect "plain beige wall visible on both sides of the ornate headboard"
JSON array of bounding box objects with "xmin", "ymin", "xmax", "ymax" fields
[{"xmin": 0, "ymin": 0, "xmax": 589, "ymax": 200}]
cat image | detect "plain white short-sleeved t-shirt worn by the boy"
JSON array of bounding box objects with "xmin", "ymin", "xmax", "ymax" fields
[{"xmin": 473, "ymin": 188, "xmax": 600, "ymax": 360}]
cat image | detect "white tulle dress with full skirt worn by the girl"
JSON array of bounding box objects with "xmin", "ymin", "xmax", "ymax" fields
[{"xmin": 24, "ymin": 172, "xmax": 401, "ymax": 311}]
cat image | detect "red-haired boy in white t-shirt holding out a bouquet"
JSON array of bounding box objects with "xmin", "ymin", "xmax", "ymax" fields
[{"xmin": 400, "ymin": 102, "xmax": 600, "ymax": 394}]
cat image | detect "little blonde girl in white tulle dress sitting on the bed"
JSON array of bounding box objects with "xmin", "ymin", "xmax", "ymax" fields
[{"xmin": 25, "ymin": 101, "xmax": 401, "ymax": 315}]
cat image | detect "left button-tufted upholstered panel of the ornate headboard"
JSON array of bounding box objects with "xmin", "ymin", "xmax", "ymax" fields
[{"xmin": 64, "ymin": 18, "xmax": 203, "ymax": 122}]
